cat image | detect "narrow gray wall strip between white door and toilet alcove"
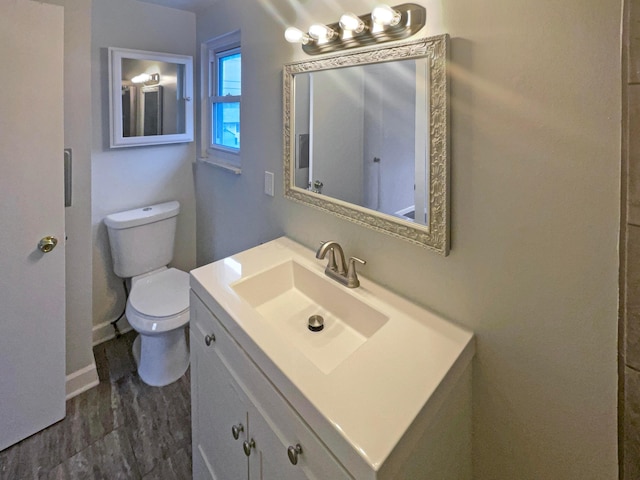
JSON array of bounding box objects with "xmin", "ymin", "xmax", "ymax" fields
[{"xmin": 42, "ymin": 0, "xmax": 95, "ymax": 382}]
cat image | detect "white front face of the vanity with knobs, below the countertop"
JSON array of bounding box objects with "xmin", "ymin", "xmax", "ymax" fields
[{"xmin": 190, "ymin": 291, "xmax": 353, "ymax": 480}]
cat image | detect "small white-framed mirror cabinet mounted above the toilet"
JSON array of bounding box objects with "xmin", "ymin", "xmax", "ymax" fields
[{"xmin": 109, "ymin": 48, "xmax": 193, "ymax": 148}]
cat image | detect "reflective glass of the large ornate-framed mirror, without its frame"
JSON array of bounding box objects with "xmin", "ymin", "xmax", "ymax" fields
[{"xmin": 295, "ymin": 58, "xmax": 428, "ymax": 225}]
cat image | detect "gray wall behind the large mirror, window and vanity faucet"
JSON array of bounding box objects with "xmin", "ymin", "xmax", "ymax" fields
[{"xmin": 196, "ymin": 0, "xmax": 621, "ymax": 480}]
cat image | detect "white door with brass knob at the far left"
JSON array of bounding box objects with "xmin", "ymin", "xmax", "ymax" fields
[{"xmin": 0, "ymin": 0, "xmax": 66, "ymax": 450}]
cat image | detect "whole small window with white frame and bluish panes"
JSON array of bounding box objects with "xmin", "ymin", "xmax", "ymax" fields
[{"xmin": 202, "ymin": 32, "xmax": 242, "ymax": 173}]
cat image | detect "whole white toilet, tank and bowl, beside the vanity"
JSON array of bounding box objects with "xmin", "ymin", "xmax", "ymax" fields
[{"xmin": 104, "ymin": 201, "xmax": 189, "ymax": 387}]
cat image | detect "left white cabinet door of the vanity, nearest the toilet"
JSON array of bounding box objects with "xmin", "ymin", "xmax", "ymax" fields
[{"xmin": 191, "ymin": 318, "xmax": 248, "ymax": 480}]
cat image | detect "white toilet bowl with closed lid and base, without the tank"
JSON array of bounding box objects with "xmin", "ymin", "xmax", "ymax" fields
[{"xmin": 126, "ymin": 268, "xmax": 189, "ymax": 387}]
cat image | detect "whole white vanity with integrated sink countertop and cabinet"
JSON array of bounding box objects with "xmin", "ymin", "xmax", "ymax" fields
[{"xmin": 190, "ymin": 237, "xmax": 474, "ymax": 480}]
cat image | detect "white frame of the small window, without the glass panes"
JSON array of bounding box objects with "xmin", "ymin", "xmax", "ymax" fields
[{"xmin": 200, "ymin": 30, "xmax": 242, "ymax": 174}]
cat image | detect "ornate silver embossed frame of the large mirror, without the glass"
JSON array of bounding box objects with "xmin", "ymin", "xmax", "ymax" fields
[{"xmin": 283, "ymin": 35, "xmax": 450, "ymax": 255}]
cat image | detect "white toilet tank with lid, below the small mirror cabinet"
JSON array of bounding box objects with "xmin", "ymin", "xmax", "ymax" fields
[{"xmin": 104, "ymin": 201, "xmax": 180, "ymax": 278}]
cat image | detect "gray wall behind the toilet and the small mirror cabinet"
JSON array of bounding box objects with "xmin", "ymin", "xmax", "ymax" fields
[{"xmin": 91, "ymin": 0, "xmax": 197, "ymax": 341}]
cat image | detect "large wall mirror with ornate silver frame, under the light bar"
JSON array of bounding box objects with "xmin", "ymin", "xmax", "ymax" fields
[{"xmin": 283, "ymin": 35, "xmax": 449, "ymax": 255}]
